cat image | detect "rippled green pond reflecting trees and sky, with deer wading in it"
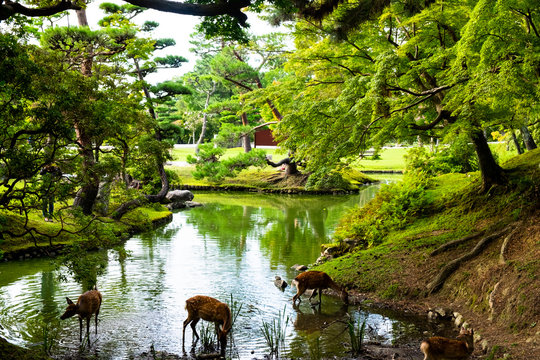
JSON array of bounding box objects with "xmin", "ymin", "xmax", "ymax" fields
[{"xmin": 0, "ymin": 186, "xmax": 448, "ymax": 359}]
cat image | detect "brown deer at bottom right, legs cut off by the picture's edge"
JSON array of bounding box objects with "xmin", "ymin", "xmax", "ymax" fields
[{"xmin": 420, "ymin": 328, "xmax": 474, "ymax": 360}]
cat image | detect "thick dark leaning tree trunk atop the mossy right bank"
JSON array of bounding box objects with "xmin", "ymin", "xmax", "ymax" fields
[{"xmin": 471, "ymin": 129, "xmax": 506, "ymax": 191}]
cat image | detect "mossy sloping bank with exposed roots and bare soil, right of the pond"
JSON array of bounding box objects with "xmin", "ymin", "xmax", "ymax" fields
[{"xmin": 317, "ymin": 149, "xmax": 540, "ymax": 359}]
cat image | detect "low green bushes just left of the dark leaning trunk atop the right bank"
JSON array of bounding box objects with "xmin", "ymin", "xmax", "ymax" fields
[{"xmin": 405, "ymin": 137, "xmax": 478, "ymax": 176}]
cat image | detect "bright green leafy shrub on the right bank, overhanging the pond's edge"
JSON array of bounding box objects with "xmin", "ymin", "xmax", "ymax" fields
[{"xmin": 335, "ymin": 172, "xmax": 432, "ymax": 248}]
